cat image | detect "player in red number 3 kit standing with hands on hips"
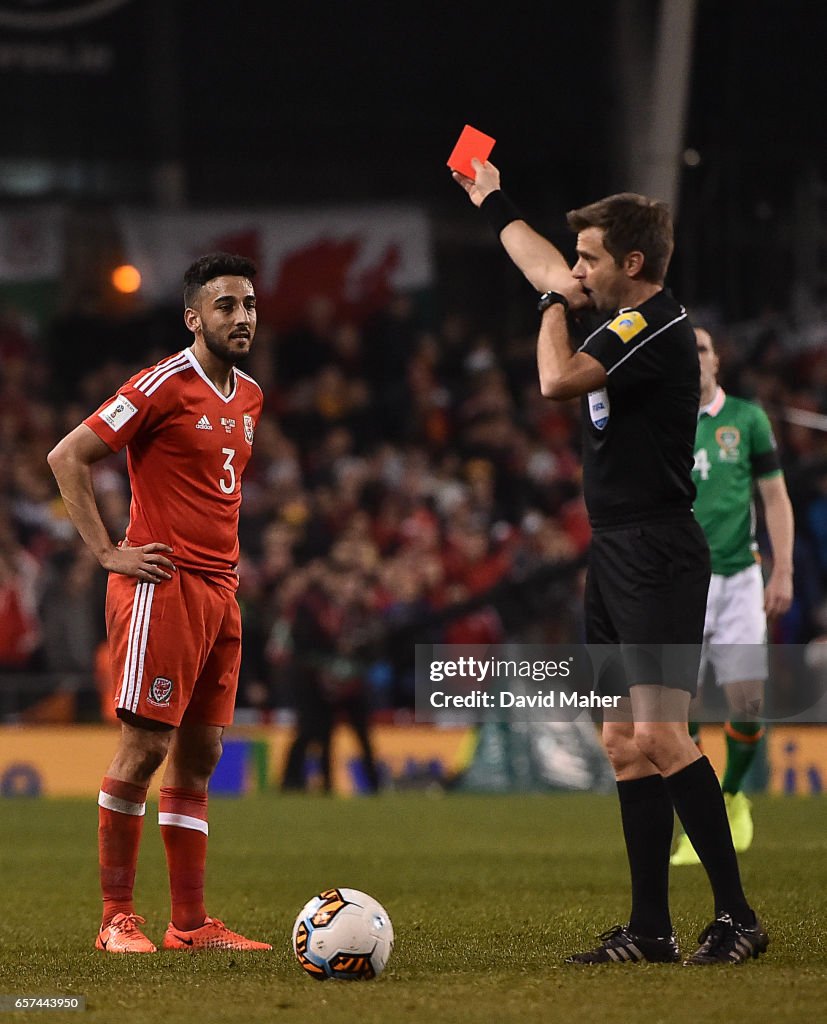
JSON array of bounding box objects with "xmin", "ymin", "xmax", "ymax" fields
[{"xmin": 48, "ymin": 253, "xmax": 271, "ymax": 953}]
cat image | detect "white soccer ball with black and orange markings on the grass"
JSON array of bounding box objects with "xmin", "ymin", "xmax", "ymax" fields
[{"xmin": 293, "ymin": 889, "xmax": 393, "ymax": 981}]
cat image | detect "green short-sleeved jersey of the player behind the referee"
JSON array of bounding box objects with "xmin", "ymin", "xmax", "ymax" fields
[{"xmin": 692, "ymin": 392, "xmax": 781, "ymax": 575}]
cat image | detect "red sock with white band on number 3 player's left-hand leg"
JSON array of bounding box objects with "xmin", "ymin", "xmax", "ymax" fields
[{"xmin": 97, "ymin": 776, "xmax": 147, "ymax": 928}]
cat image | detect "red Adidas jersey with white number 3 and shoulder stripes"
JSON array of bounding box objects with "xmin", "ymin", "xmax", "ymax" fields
[{"xmin": 84, "ymin": 348, "xmax": 262, "ymax": 589}]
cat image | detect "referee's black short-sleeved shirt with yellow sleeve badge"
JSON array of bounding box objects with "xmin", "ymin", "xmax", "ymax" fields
[{"xmin": 580, "ymin": 291, "xmax": 700, "ymax": 528}]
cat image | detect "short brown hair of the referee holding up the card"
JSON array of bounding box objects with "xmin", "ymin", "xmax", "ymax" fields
[{"xmin": 566, "ymin": 193, "xmax": 674, "ymax": 285}]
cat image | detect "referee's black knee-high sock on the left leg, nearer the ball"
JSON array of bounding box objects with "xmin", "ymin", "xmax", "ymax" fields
[{"xmin": 617, "ymin": 775, "xmax": 674, "ymax": 938}]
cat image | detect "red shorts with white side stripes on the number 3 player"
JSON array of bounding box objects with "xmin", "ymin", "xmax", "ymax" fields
[{"xmin": 106, "ymin": 569, "xmax": 242, "ymax": 726}]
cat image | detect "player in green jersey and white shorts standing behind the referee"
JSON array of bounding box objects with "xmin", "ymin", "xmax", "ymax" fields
[{"xmin": 671, "ymin": 328, "xmax": 793, "ymax": 865}]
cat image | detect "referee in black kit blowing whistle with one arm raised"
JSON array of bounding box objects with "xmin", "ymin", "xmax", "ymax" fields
[{"xmin": 453, "ymin": 160, "xmax": 769, "ymax": 965}]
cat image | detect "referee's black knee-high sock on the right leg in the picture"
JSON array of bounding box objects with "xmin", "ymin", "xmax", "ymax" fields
[{"xmin": 665, "ymin": 757, "xmax": 755, "ymax": 928}]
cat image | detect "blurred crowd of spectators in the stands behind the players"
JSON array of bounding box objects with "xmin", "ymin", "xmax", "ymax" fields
[{"xmin": 0, "ymin": 284, "xmax": 827, "ymax": 724}]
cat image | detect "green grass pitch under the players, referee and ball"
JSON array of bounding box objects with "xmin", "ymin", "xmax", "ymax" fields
[{"xmin": 0, "ymin": 794, "xmax": 827, "ymax": 1024}]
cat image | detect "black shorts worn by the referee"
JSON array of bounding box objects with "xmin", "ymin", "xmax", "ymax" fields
[{"xmin": 584, "ymin": 513, "xmax": 710, "ymax": 696}]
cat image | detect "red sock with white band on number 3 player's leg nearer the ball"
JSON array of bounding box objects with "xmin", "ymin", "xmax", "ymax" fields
[{"xmin": 158, "ymin": 785, "xmax": 209, "ymax": 932}]
